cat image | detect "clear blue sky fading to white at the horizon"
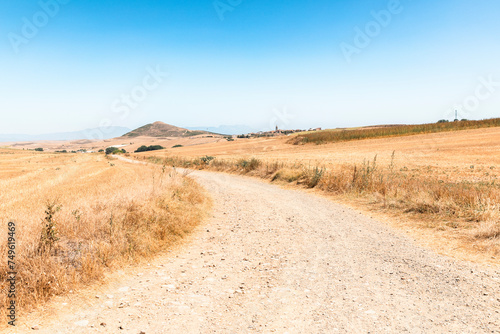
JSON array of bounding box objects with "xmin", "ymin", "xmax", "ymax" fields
[{"xmin": 0, "ymin": 0, "xmax": 500, "ymax": 134}]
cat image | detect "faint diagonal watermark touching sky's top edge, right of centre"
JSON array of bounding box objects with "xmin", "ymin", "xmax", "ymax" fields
[{"xmin": 340, "ymin": 0, "xmax": 404, "ymax": 63}]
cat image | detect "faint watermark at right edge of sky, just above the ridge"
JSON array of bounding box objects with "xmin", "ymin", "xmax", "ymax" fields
[{"xmin": 445, "ymin": 74, "xmax": 500, "ymax": 119}]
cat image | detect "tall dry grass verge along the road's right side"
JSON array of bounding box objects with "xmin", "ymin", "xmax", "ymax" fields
[{"xmin": 149, "ymin": 153, "xmax": 500, "ymax": 256}]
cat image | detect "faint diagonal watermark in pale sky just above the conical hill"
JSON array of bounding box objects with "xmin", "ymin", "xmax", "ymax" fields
[{"xmin": 85, "ymin": 65, "xmax": 169, "ymax": 140}]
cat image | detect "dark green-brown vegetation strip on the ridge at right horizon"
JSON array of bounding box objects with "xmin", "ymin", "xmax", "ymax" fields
[{"xmin": 289, "ymin": 118, "xmax": 500, "ymax": 145}]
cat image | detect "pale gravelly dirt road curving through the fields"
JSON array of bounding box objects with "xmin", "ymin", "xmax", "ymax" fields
[{"xmin": 10, "ymin": 172, "xmax": 500, "ymax": 333}]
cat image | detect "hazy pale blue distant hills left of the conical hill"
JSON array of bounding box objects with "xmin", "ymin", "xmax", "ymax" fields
[{"xmin": 0, "ymin": 126, "xmax": 130, "ymax": 142}]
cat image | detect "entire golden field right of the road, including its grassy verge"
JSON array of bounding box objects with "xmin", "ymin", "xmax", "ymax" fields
[{"xmin": 136, "ymin": 128, "xmax": 500, "ymax": 262}]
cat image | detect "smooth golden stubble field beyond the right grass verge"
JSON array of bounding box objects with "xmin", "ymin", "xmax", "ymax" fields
[{"xmin": 141, "ymin": 128, "xmax": 500, "ymax": 180}]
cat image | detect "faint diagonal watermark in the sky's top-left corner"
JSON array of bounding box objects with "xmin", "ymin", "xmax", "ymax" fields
[{"xmin": 7, "ymin": 0, "xmax": 71, "ymax": 53}]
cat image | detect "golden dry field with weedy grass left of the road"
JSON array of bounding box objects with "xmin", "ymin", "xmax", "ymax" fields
[{"xmin": 0, "ymin": 149, "xmax": 210, "ymax": 324}]
